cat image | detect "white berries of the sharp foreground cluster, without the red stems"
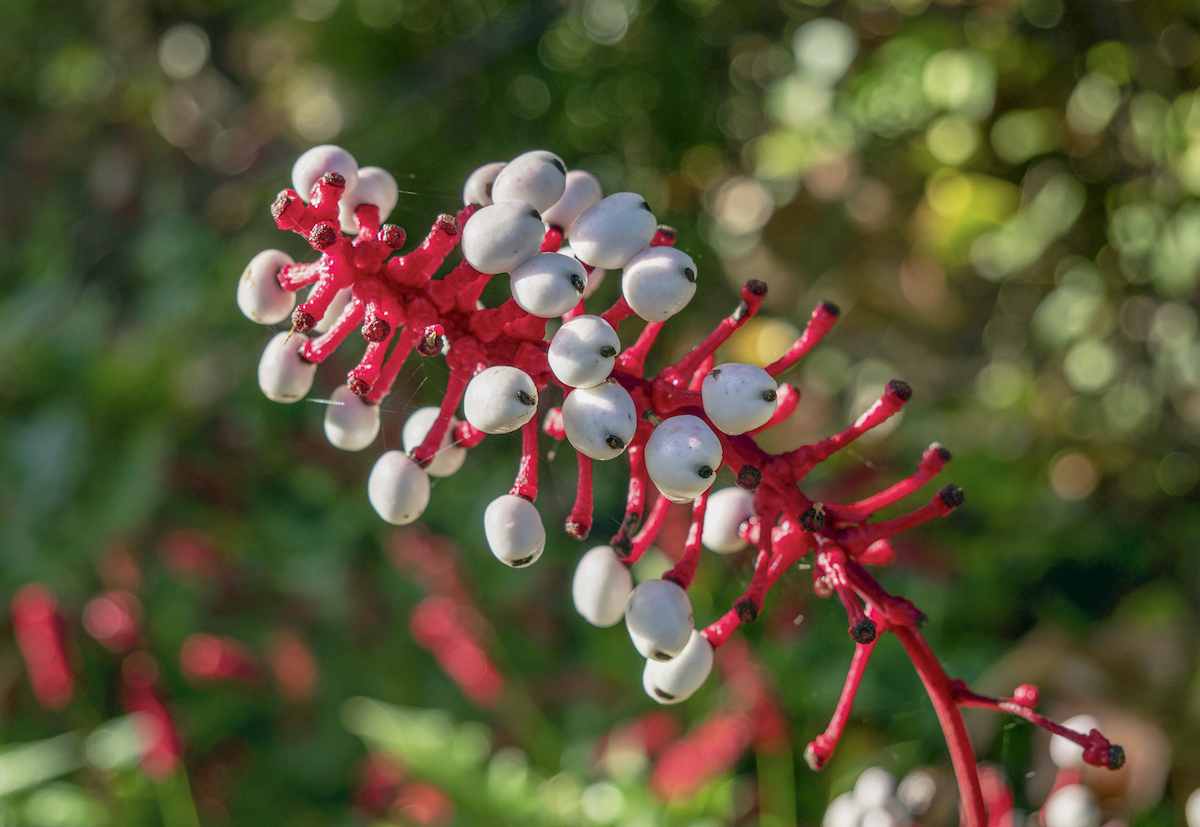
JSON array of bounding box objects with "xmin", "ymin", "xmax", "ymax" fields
[{"xmin": 238, "ymin": 145, "xmax": 792, "ymax": 703}]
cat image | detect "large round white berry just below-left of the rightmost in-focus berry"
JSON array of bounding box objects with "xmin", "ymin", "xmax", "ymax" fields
[{"xmin": 646, "ymin": 414, "xmax": 721, "ymax": 503}]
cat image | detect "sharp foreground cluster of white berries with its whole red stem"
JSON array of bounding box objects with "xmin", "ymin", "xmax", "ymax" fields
[{"xmin": 238, "ymin": 145, "xmax": 1123, "ymax": 823}]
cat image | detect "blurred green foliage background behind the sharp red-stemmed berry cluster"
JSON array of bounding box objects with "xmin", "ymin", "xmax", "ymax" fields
[{"xmin": 0, "ymin": 0, "xmax": 1200, "ymax": 827}]
